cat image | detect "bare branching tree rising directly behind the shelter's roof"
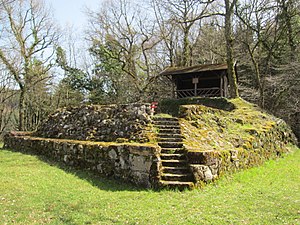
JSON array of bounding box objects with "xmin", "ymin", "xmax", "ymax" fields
[{"xmin": 152, "ymin": 0, "xmax": 214, "ymax": 66}]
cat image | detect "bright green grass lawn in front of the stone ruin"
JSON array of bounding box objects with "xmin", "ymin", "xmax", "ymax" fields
[{"xmin": 0, "ymin": 144, "xmax": 300, "ymax": 224}]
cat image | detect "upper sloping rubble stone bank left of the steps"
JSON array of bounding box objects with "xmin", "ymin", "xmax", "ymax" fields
[{"xmin": 34, "ymin": 103, "xmax": 151, "ymax": 142}]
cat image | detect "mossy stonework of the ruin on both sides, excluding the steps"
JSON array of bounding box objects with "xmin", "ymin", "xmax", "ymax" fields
[{"xmin": 4, "ymin": 100, "xmax": 296, "ymax": 188}]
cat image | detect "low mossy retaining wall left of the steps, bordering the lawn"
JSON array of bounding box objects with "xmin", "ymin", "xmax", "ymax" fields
[{"xmin": 4, "ymin": 132, "xmax": 158, "ymax": 188}]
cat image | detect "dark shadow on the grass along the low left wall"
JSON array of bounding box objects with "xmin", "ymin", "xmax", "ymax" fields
[{"xmin": 0, "ymin": 146, "xmax": 148, "ymax": 191}]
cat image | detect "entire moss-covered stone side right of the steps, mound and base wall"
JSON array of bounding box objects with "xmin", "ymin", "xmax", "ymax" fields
[{"xmin": 180, "ymin": 99, "xmax": 297, "ymax": 186}]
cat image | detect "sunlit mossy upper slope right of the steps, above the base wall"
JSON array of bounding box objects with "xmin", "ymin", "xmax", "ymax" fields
[{"xmin": 180, "ymin": 99, "xmax": 296, "ymax": 151}]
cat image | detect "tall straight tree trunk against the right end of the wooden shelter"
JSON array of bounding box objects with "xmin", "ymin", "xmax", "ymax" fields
[{"xmin": 224, "ymin": 0, "xmax": 239, "ymax": 98}]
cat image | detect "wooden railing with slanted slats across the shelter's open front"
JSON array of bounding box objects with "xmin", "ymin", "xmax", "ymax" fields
[{"xmin": 175, "ymin": 87, "xmax": 221, "ymax": 98}]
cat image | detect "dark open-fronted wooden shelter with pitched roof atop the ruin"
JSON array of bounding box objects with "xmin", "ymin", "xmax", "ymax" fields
[{"xmin": 161, "ymin": 64, "xmax": 232, "ymax": 98}]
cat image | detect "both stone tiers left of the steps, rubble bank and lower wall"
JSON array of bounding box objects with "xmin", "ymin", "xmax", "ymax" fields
[{"xmin": 4, "ymin": 104, "xmax": 159, "ymax": 188}]
